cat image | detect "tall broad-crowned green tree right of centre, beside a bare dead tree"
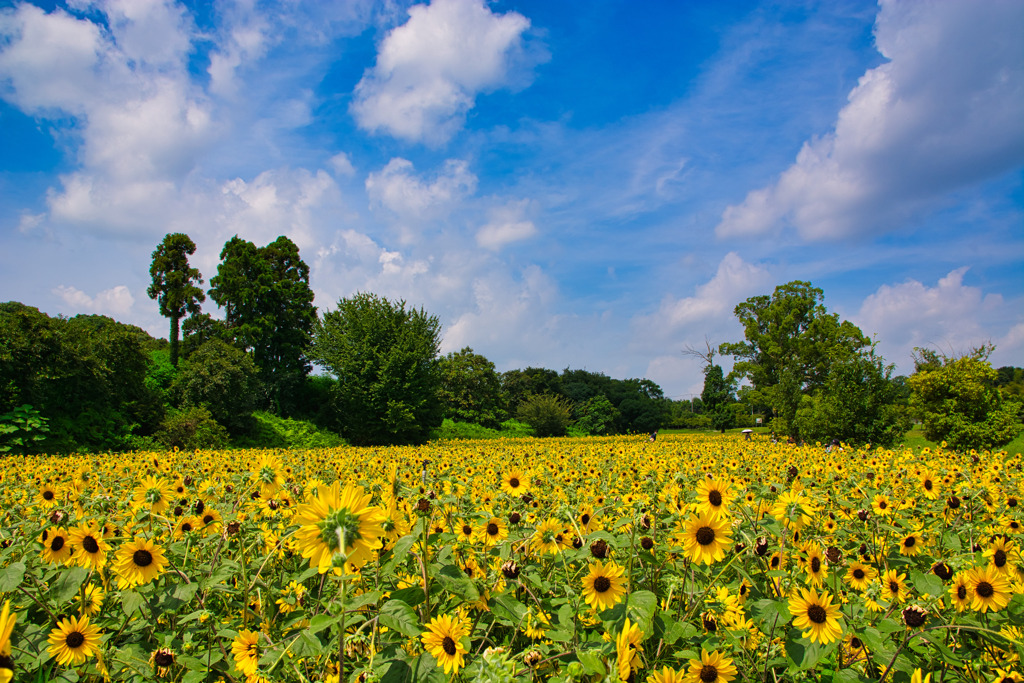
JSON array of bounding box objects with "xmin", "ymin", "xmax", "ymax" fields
[{"xmin": 719, "ymin": 281, "xmax": 870, "ymax": 436}]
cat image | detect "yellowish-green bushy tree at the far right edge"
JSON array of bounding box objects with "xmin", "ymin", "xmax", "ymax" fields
[{"xmin": 909, "ymin": 345, "xmax": 1024, "ymax": 451}]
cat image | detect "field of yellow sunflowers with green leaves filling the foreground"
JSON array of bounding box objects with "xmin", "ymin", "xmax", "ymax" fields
[{"xmin": 0, "ymin": 435, "xmax": 1024, "ymax": 683}]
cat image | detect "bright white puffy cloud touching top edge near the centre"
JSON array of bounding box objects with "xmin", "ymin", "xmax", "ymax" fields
[{"xmin": 351, "ymin": 0, "xmax": 529, "ymax": 144}]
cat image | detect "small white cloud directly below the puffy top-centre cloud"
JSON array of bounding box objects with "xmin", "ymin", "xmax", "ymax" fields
[{"xmin": 366, "ymin": 158, "xmax": 476, "ymax": 218}]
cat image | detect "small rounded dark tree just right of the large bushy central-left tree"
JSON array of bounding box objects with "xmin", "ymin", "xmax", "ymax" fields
[{"xmin": 438, "ymin": 346, "xmax": 505, "ymax": 429}]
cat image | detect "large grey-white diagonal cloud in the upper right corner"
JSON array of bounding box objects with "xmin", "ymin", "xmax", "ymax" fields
[{"xmin": 716, "ymin": 0, "xmax": 1024, "ymax": 240}]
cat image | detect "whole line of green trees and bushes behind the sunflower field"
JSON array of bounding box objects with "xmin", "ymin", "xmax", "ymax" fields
[{"xmin": 0, "ymin": 233, "xmax": 1024, "ymax": 453}]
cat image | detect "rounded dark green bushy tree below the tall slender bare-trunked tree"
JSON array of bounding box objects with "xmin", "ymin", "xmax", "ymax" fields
[{"xmin": 170, "ymin": 339, "xmax": 260, "ymax": 434}]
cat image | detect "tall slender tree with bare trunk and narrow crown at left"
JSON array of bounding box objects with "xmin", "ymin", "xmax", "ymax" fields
[{"xmin": 146, "ymin": 232, "xmax": 206, "ymax": 368}]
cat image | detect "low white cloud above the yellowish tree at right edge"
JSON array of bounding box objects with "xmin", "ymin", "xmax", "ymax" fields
[{"xmin": 853, "ymin": 267, "xmax": 1024, "ymax": 372}]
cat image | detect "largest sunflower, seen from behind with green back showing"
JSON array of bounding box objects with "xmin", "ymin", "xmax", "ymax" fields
[{"xmin": 295, "ymin": 481, "xmax": 385, "ymax": 573}]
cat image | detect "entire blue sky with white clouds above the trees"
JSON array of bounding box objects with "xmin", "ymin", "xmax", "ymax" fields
[{"xmin": 0, "ymin": 0, "xmax": 1024, "ymax": 397}]
